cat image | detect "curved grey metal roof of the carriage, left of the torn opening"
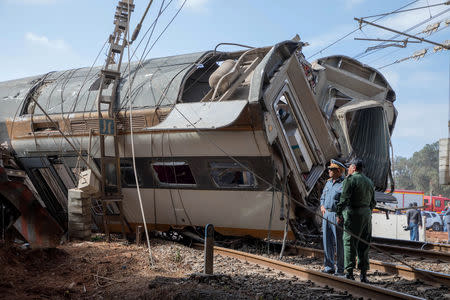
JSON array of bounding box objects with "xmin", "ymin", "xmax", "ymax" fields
[{"xmin": 0, "ymin": 51, "xmax": 212, "ymax": 121}]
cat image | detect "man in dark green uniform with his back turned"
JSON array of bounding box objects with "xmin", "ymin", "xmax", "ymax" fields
[{"xmin": 336, "ymin": 159, "xmax": 376, "ymax": 283}]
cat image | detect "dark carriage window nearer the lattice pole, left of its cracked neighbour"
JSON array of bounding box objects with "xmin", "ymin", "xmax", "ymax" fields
[{"xmin": 152, "ymin": 162, "xmax": 195, "ymax": 185}]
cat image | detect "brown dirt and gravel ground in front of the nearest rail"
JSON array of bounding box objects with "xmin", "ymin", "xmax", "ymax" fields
[{"xmin": 0, "ymin": 239, "xmax": 354, "ymax": 300}]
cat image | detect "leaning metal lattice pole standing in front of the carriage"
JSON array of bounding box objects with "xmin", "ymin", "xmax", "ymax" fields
[{"xmin": 97, "ymin": 0, "xmax": 134, "ymax": 241}]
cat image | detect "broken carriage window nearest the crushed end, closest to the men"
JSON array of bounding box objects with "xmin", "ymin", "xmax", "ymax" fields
[{"xmin": 211, "ymin": 163, "xmax": 256, "ymax": 188}]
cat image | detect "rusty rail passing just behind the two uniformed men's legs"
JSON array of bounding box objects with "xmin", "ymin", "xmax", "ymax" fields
[{"xmin": 290, "ymin": 246, "xmax": 450, "ymax": 286}]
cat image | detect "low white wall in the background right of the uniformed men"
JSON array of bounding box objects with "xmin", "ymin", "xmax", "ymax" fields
[{"xmin": 372, "ymin": 213, "xmax": 425, "ymax": 241}]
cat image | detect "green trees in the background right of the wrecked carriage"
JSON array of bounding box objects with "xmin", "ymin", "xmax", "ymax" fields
[{"xmin": 393, "ymin": 142, "xmax": 450, "ymax": 198}]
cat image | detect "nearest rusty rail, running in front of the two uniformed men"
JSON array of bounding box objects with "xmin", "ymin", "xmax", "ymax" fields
[{"xmin": 194, "ymin": 244, "xmax": 423, "ymax": 299}]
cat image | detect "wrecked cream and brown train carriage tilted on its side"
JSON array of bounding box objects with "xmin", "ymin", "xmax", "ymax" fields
[{"xmin": 0, "ymin": 41, "xmax": 397, "ymax": 241}]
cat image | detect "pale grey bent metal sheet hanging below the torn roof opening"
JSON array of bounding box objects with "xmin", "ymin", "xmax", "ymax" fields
[{"xmin": 148, "ymin": 100, "xmax": 248, "ymax": 131}]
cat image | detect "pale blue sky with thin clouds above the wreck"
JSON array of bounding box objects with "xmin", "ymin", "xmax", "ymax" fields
[{"xmin": 0, "ymin": 0, "xmax": 450, "ymax": 157}]
